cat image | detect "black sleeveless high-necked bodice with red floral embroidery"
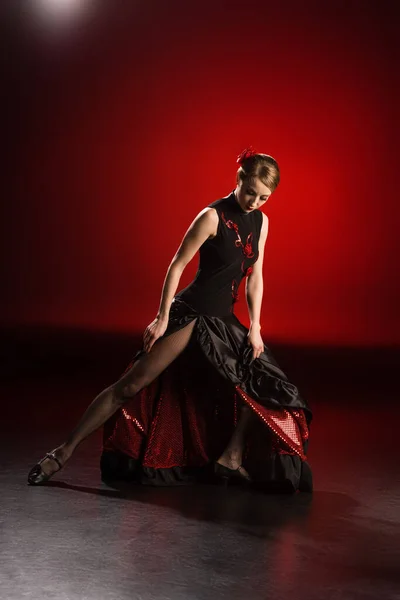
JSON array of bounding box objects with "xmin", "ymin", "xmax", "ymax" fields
[{"xmin": 175, "ymin": 191, "xmax": 263, "ymax": 316}]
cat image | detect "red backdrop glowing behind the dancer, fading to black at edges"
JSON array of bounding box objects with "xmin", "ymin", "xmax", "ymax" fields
[{"xmin": 1, "ymin": 0, "xmax": 400, "ymax": 345}]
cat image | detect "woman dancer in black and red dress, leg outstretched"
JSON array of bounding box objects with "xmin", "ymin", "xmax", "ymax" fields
[{"xmin": 28, "ymin": 148, "xmax": 312, "ymax": 492}]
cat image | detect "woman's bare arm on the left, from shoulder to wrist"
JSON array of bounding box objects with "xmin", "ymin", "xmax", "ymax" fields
[{"xmin": 156, "ymin": 207, "xmax": 218, "ymax": 320}]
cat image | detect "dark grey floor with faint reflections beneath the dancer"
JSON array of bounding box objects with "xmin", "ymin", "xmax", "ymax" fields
[{"xmin": 0, "ymin": 332, "xmax": 400, "ymax": 600}]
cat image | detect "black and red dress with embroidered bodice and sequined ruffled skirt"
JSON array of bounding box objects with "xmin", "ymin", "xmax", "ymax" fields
[{"xmin": 100, "ymin": 192, "xmax": 312, "ymax": 491}]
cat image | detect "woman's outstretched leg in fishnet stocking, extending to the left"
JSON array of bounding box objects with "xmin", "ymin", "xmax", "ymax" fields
[{"xmin": 27, "ymin": 319, "xmax": 197, "ymax": 475}]
